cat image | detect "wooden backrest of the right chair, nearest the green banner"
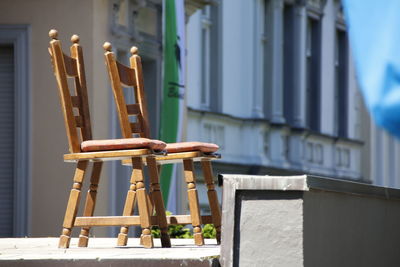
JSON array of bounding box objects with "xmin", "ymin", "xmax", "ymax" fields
[{"xmin": 103, "ymin": 42, "xmax": 150, "ymax": 138}]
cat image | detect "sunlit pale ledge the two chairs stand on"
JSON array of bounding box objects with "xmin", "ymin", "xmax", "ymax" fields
[{"xmin": 0, "ymin": 238, "xmax": 220, "ymax": 267}]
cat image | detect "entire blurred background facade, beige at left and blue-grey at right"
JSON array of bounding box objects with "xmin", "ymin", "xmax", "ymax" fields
[{"xmin": 0, "ymin": 0, "xmax": 400, "ymax": 240}]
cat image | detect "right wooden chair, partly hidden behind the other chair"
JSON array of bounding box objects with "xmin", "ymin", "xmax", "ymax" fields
[{"xmin": 103, "ymin": 42, "xmax": 221, "ymax": 245}]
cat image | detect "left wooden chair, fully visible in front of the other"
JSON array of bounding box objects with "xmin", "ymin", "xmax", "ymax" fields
[{"xmin": 49, "ymin": 30, "xmax": 171, "ymax": 248}]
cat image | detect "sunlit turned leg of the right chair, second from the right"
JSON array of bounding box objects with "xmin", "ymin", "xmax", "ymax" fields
[{"xmin": 183, "ymin": 159, "xmax": 204, "ymax": 246}]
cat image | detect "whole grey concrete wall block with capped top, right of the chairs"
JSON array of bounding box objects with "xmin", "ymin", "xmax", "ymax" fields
[{"xmin": 221, "ymin": 175, "xmax": 400, "ymax": 266}]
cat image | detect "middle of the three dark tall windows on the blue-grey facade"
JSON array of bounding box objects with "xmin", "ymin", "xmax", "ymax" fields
[{"xmin": 306, "ymin": 16, "xmax": 321, "ymax": 132}]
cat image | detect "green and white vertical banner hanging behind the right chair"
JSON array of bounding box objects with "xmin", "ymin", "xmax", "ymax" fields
[{"xmin": 160, "ymin": 0, "xmax": 185, "ymax": 205}]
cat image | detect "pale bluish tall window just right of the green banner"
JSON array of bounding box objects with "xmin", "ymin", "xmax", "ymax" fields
[{"xmin": 200, "ymin": 2, "xmax": 222, "ymax": 112}]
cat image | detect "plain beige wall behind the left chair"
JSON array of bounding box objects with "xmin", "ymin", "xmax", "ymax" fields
[{"xmin": 0, "ymin": 0, "xmax": 110, "ymax": 236}]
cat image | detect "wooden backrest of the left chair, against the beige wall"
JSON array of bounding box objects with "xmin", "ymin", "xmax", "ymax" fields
[{"xmin": 49, "ymin": 29, "xmax": 92, "ymax": 153}]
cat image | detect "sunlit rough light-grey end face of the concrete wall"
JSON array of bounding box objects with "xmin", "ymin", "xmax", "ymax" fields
[{"xmin": 238, "ymin": 193, "xmax": 303, "ymax": 266}]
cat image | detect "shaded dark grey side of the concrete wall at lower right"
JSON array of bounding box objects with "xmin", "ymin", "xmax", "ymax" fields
[{"xmin": 303, "ymin": 190, "xmax": 400, "ymax": 267}]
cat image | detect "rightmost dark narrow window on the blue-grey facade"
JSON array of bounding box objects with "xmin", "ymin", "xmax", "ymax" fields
[{"xmin": 334, "ymin": 28, "xmax": 348, "ymax": 137}]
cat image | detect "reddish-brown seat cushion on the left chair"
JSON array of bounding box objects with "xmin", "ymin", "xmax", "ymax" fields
[{"xmin": 81, "ymin": 138, "xmax": 166, "ymax": 152}]
